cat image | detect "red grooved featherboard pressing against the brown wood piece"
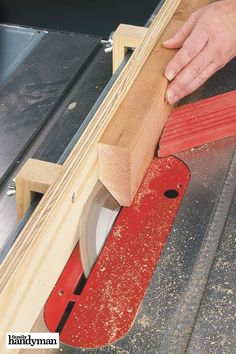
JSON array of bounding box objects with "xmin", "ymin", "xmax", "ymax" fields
[{"xmin": 158, "ymin": 91, "xmax": 236, "ymax": 157}]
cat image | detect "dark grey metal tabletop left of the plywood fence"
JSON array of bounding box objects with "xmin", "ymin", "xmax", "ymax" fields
[{"xmin": 0, "ymin": 26, "xmax": 111, "ymax": 250}]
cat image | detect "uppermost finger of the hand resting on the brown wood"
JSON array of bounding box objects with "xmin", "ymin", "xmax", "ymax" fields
[{"xmin": 163, "ymin": 11, "xmax": 200, "ymax": 49}]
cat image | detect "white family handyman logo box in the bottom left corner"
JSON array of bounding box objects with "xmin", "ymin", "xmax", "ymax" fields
[{"xmin": 6, "ymin": 333, "xmax": 59, "ymax": 349}]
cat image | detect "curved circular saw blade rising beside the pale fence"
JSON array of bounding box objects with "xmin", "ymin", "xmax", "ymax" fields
[{"xmin": 79, "ymin": 181, "xmax": 120, "ymax": 278}]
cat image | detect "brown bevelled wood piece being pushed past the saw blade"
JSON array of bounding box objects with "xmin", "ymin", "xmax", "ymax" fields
[{"xmin": 98, "ymin": 0, "xmax": 214, "ymax": 206}]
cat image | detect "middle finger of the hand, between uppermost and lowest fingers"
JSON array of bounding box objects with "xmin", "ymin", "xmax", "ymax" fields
[{"xmin": 165, "ymin": 25, "xmax": 208, "ymax": 81}]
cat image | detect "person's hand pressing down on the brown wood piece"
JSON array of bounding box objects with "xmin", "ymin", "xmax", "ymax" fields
[{"xmin": 163, "ymin": 0, "xmax": 236, "ymax": 104}]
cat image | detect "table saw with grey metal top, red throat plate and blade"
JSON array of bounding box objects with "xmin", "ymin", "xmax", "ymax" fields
[{"xmin": 0, "ymin": 0, "xmax": 236, "ymax": 353}]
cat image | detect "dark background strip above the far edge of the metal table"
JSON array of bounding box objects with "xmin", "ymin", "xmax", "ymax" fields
[{"xmin": 0, "ymin": 0, "xmax": 159, "ymax": 37}]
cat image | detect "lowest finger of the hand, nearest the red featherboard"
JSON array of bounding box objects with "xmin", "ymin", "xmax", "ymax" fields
[{"xmin": 166, "ymin": 62, "xmax": 220, "ymax": 104}]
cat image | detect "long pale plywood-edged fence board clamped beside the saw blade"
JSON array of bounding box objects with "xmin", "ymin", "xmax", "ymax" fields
[{"xmin": 0, "ymin": 0, "xmax": 183, "ymax": 353}]
